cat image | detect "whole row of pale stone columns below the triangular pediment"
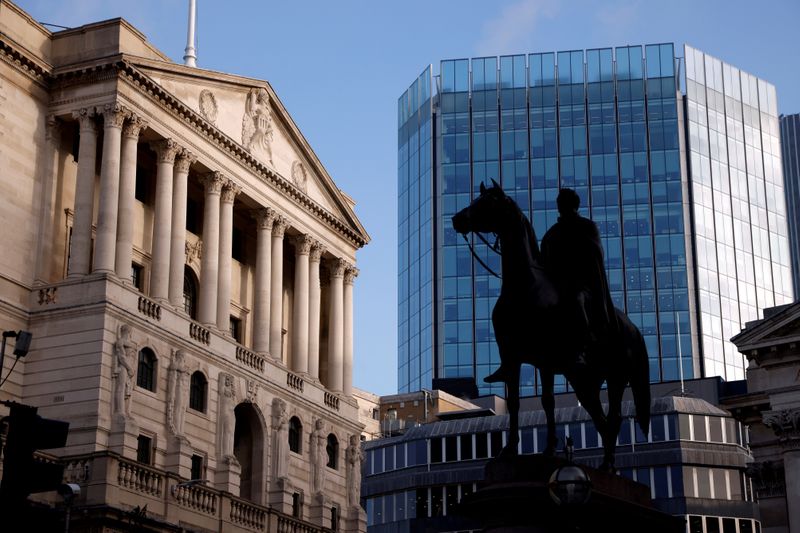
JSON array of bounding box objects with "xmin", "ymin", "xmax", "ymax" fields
[{"xmin": 67, "ymin": 104, "xmax": 358, "ymax": 396}]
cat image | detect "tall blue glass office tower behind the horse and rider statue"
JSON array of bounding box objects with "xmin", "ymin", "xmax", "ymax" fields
[{"xmin": 398, "ymin": 44, "xmax": 792, "ymax": 395}]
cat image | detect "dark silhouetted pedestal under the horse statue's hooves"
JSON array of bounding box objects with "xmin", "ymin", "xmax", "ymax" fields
[{"xmin": 456, "ymin": 455, "xmax": 685, "ymax": 533}]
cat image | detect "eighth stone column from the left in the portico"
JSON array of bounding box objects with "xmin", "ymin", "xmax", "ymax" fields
[{"xmin": 253, "ymin": 207, "xmax": 276, "ymax": 353}]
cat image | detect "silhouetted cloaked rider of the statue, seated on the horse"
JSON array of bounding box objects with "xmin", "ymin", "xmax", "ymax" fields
[{"xmin": 484, "ymin": 189, "xmax": 619, "ymax": 383}]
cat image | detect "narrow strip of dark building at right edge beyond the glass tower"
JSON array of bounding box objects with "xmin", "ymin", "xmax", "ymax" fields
[{"xmin": 780, "ymin": 113, "xmax": 800, "ymax": 300}]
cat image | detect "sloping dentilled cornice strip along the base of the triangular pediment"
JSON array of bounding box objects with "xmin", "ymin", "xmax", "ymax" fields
[{"xmin": 110, "ymin": 59, "xmax": 367, "ymax": 248}]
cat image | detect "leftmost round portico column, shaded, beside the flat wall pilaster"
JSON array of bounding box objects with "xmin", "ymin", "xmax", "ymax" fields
[{"xmin": 67, "ymin": 108, "xmax": 97, "ymax": 277}]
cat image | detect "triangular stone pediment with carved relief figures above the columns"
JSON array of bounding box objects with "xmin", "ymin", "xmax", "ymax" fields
[{"xmin": 126, "ymin": 58, "xmax": 366, "ymax": 237}]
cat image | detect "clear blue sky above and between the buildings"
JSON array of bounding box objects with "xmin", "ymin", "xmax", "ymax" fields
[{"xmin": 17, "ymin": 0, "xmax": 800, "ymax": 394}]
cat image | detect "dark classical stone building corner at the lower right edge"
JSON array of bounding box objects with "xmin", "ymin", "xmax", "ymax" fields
[{"xmin": 723, "ymin": 303, "xmax": 800, "ymax": 533}]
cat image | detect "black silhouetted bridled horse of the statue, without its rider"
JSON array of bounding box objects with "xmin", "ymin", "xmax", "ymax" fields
[{"xmin": 452, "ymin": 180, "xmax": 650, "ymax": 472}]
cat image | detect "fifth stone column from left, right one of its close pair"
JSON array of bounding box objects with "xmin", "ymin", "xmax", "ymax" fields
[{"xmin": 169, "ymin": 150, "xmax": 197, "ymax": 309}]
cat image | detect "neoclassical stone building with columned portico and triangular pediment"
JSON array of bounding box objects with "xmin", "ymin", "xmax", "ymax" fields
[{"xmin": 0, "ymin": 0, "xmax": 369, "ymax": 531}]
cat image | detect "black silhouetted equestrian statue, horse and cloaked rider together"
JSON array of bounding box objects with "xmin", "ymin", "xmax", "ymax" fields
[{"xmin": 453, "ymin": 180, "xmax": 650, "ymax": 471}]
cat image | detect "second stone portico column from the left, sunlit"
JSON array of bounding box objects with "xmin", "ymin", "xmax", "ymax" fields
[{"xmin": 92, "ymin": 104, "xmax": 126, "ymax": 272}]
